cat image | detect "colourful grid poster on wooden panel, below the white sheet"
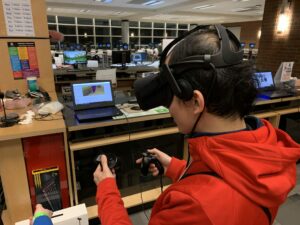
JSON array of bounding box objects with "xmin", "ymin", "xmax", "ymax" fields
[{"xmin": 7, "ymin": 42, "xmax": 40, "ymax": 80}]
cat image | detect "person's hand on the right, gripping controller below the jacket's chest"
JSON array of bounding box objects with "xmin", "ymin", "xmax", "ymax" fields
[{"xmin": 136, "ymin": 148, "xmax": 172, "ymax": 176}]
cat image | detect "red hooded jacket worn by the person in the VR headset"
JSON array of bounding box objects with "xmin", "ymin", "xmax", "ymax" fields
[{"xmin": 96, "ymin": 120, "xmax": 300, "ymax": 225}]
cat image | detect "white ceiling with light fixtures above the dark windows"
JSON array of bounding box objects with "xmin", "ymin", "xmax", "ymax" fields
[{"xmin": 46, "ymin": 0, "xmax": 265, "ymax": 24}]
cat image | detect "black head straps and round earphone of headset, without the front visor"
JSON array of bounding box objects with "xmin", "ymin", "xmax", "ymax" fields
[{"xmin": 160, "ymin": 25, "xmax": 243, "ymax": 101}]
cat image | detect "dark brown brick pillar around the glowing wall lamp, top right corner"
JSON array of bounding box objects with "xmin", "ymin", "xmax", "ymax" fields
[{"xmin": 256, "ymin": 0, "xmax": 300, "ymax": 78}]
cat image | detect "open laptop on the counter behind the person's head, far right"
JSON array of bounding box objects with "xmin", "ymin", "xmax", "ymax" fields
[{"xmin": 255, "ymin": 72, "xmax": 293, "ymax": 99}]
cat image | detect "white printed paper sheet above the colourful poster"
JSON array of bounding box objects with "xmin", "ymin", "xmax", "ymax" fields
[{"xmin": 2, "ymin": 0, "xmax": 35, "ymax": 37}]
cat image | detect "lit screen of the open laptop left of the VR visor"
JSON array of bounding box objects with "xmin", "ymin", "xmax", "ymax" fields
[{"xmin": 72, "ymin": 81, "xmax": 115, "ymax": 110}]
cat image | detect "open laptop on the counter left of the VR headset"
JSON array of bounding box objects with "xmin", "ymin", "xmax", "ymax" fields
[{"xmin": 71, "ymin": 80, "xmax": 123, "ymax": 122}]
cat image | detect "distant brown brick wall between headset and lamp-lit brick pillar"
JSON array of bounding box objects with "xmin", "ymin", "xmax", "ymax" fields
[{"xmin": 222, "ymin": 21, "xmax": 262, "ymax": 48}]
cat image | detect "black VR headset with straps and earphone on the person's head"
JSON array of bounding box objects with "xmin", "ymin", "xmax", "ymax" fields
[{"xmin": 134, "ymin": 25, "xmax": 243, "ymax": 110}]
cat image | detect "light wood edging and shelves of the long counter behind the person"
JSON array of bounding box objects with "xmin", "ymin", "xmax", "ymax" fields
[{"xmin": 66, "ymin": 97, "xmax": 300, "ymax": 219}]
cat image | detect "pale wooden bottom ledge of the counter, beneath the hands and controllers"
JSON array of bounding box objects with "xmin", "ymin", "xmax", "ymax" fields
[{"xmin": 87, "ymin": 186, "xmax": 168, "ymax": 219}]
